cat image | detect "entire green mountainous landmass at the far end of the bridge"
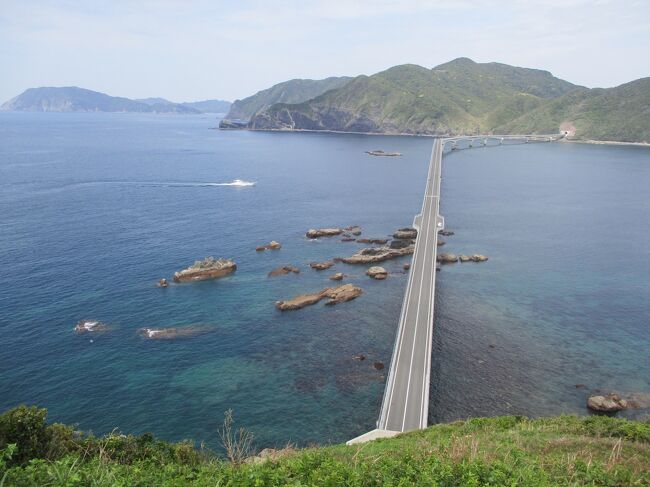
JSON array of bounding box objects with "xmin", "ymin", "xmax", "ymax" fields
[{"xmin": 221, "ymin": 58, "xmax": 650, "ymax": 142}]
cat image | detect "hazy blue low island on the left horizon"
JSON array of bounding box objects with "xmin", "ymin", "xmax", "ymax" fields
[{"xmin": 0, "ymin": 86, "xmax": 230, "ymax": 114}]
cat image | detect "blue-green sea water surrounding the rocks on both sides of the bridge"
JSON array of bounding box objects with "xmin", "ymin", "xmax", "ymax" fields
[{"xmin": 0, "ymin": 113, "xmax": 650, "ymax": 446}]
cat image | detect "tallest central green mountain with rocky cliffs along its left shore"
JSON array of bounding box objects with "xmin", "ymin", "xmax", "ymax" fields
[{"xmin": 250, "ymin": 58, "xmax": 577, "ymax": 134}]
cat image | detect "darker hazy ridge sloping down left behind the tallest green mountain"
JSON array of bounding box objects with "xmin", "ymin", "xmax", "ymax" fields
[{"xmin": 226, "ymin": 77, "xmax": 351, "ymax": 120}]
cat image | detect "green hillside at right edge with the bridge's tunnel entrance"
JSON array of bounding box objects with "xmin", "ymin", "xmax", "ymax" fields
[{"xmin": 497, "ymin": 78, "xmax": 650, "ymax": 142}]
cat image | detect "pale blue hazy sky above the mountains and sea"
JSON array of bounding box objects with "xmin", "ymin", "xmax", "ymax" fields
[{"xmin": 0, "ymin": 0, "xmax": 650, "ymax": 102}]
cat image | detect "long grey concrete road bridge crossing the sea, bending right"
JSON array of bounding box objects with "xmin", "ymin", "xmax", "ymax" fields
[{"xmin": 348, "ymin": 134, "xmax": 564, "ymax": 444}]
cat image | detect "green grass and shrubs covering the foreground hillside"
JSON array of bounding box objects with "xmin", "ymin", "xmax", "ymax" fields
[{"xmin": 0, "ymin": 406, "xmax": 650, "ymax": 486}]
